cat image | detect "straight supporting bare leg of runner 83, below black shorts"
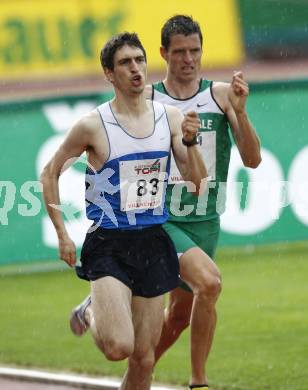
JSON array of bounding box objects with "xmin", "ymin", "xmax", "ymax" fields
[{"xmin": 120, "ymin": 296, "xmax": 164, "ymax": 390}]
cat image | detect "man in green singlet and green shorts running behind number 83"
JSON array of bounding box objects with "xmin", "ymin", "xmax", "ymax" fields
[{"xmin": 147, "ymin": 15, "xmax": 261, "ymax": 390}]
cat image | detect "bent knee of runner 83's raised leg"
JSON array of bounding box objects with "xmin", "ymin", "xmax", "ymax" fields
[{"xmin": 96, "ymin": 339, "xmax": 134, "ymax": 361}]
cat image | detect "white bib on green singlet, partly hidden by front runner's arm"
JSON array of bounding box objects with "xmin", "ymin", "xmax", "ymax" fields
[{"xmin": 168, "ymin": 131, "xmax": 216, "ymax": 184}]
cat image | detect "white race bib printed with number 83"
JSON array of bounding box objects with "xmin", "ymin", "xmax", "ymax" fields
[{"xmin": 120, "ymin": 157, "xmax": 168, "ymax": 211}]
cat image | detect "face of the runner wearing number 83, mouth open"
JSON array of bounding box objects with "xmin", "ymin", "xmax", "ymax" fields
[{"xmin": 105, "ymin": 45, "xmax": 147, "ymax": 95}]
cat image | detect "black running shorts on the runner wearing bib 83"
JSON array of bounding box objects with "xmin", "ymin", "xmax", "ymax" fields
[{"xmin": 76, "ymin": 225, "xmax": 179, "ymax": 298}]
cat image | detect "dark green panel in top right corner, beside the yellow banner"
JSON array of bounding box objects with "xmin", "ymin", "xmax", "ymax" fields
[{"xmin": 238, "ymin": 0, "xmax": 308, "ymax": 60}]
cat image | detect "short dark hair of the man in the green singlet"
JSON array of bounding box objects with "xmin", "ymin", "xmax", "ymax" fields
[{"xmin": 161, "ymin": 15, "xmax": 203, "ymax": 50}]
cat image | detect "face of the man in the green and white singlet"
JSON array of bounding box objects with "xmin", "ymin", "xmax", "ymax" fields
[{"xmin": 161, "ymin": 34, "xmax": 202, "ymax": 82}]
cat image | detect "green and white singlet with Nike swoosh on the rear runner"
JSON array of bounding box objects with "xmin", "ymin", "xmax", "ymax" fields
[{"xmin": 152, "ymin": 79, "xmax": 231, "ymax": 222}]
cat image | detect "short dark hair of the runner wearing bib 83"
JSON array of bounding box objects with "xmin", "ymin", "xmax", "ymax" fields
[{"xmin": 100, "ymin": 32, "xmax": 147, "ymax": 70}]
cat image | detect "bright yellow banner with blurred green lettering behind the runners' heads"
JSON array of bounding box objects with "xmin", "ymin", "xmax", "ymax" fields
[{"xmin": 0, "ymin": 0, "xmax": 244, "ymax": 80}]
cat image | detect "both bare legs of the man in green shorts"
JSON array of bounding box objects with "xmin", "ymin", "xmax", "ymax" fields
[{"xmin": 155, "ymin": 247, "xmax": 221, "ymax": 384}]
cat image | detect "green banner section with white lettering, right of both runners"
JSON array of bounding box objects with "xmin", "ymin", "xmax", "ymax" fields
[{"xmin": 220, "ymin": 80, "xmax": 308, "ymax": 245}]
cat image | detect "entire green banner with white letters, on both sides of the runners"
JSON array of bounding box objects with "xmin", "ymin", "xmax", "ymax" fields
[{"xmin": 0, "ymin": 80, "xmax": 308, "ymax": 264}]
